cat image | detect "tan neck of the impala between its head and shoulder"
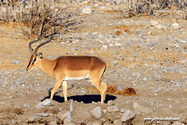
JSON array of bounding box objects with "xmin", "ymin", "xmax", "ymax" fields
[{"xmin": 38, "ymin": 58, "xmax": 56, "ymax": 77}]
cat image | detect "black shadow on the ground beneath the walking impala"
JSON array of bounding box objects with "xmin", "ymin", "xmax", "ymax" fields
[{"xmin": 41, "ymin": 91, "xmax": 116, "ymax": 103}]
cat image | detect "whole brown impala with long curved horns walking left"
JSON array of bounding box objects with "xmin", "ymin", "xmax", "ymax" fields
[{"xmin": 26, "ymin": 25, "xmax": 107, "ymax": 103}]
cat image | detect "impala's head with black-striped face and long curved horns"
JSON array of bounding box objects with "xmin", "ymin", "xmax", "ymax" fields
[{"xmin": 26, "ymin": 25, "xmax": 53, "ymax": 71}]
